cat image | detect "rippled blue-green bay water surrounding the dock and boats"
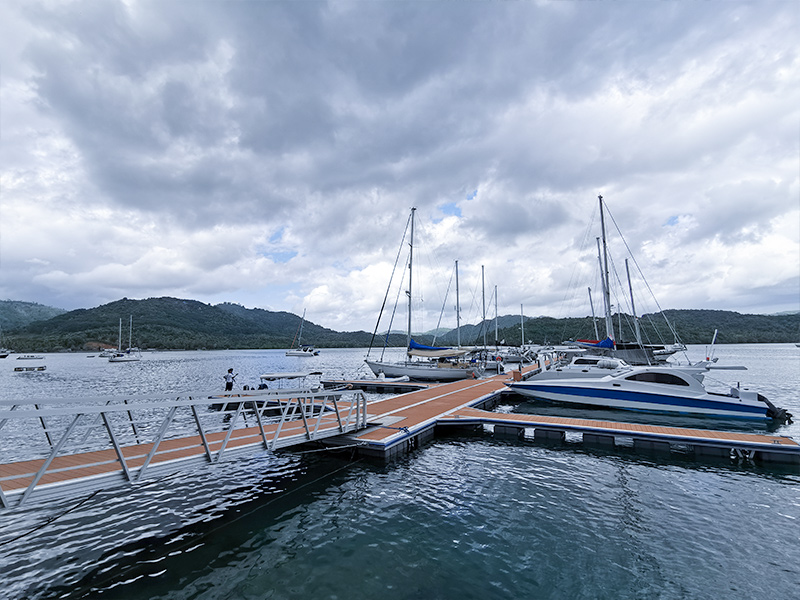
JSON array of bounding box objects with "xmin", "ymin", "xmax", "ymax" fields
[{"xmin": 0, "ymin": 344, "xmax": 800, "ymax": 600}]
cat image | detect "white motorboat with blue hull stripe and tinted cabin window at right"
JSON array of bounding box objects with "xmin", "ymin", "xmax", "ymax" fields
[{"xmin": 506, "ymin": 366, "xmax": 792, "ymax": 422}]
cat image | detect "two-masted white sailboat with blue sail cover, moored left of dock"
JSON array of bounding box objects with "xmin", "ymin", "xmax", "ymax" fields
[{"xmin": 364, "ymin": 208, "xmax": 483, "ymax": 381}]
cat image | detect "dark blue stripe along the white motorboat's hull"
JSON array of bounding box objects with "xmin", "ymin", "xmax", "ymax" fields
[{"xmin": 510, "ymin": 383, "xmax": 767, "ymax": 417}]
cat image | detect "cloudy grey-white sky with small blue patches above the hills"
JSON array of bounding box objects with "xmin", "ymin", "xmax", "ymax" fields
[{"xmin": 0, "ymin": 0, "xmax": 800, "ymax": 331}]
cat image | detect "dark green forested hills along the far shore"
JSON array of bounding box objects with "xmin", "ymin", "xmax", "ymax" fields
[{"xmin": 0, "ymin": 297, "xmax": 800, "ymax": 352}]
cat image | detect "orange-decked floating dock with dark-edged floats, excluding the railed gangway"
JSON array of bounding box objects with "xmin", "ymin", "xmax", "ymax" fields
[{"xmin": 324, "ymin": 366, "xmax": 800, "ymax": 465}]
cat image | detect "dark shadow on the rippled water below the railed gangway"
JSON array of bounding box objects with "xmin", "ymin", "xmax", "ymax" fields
[{"xmin": 5, "ymin": 453, "xmax": 360, "ymax": 600}]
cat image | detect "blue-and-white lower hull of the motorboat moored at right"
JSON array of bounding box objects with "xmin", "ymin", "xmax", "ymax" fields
[{"xmin": 509, "ymin": 382, "xmax": 771, "ymax": 420}]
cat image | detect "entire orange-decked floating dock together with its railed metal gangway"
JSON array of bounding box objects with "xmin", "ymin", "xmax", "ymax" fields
[{"xmin": 0, "ymin": 366, "xmax": 800, "ymax": 508}]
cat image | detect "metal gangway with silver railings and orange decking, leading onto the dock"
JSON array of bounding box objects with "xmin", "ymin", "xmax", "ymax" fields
[{"xmin": 0, "ymin": 389, "xmax": 367, "ymax": 508}]
